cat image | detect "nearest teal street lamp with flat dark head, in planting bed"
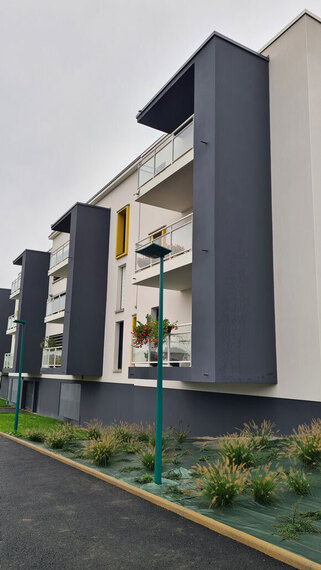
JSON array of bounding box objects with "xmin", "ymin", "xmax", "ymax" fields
[{"xmin": 136, "ymin": 242, "xmax": 171, "ymax": 485}]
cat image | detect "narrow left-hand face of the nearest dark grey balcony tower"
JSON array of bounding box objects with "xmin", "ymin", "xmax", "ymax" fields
[{"xmin": 192, "ymin": 41, "xmax": 216, "ymax": 382}]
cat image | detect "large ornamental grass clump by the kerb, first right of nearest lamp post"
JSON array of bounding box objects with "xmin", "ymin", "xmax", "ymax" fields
[{"xmin": 190, "ymin": 457, "xmax": 248, "ymax": 507}]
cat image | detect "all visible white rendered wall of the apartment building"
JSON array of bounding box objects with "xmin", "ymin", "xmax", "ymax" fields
[{"xmin": 39, "ymin": 15, "xmax": 321, "ymax": 401}]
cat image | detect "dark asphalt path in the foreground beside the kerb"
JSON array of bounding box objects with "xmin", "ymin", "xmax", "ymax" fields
[{"xmin": 0, "ymin": 437, "xmax": 289, "ymax": 570}]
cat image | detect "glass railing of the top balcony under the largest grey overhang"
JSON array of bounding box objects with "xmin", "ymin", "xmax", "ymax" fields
[{"xmin": 138, "ymin": 118, "xmax": 194, "ymax": 188}]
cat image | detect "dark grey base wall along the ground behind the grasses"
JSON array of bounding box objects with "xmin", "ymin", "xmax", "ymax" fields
[{"xmin": 33, "ymin": 378, "xmax": 321, "ymax": 436}]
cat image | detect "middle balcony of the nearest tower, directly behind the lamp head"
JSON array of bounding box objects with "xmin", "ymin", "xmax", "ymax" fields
[{"xmin": 132, "ymin": 214, "xmax": 193, "ymax": 291}]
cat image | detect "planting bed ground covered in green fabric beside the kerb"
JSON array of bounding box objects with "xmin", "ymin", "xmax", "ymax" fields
[{"xmin": 16, "ymin": 422, "xmax": 321, "ymax": 564}]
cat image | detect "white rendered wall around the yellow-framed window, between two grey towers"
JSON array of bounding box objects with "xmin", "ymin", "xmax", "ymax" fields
[{"xmin": 96, "ymin": 172, "xmax": 191, "ymax": 384}]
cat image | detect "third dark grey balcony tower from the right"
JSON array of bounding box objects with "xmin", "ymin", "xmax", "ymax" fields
[{"xmin": 13, "ymin": 250, "xmax": 50, "ymax": 374}]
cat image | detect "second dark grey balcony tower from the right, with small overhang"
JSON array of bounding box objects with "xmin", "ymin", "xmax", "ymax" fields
[{"xmin": 45, "ymin": 203, "xmax": 110, "ymax": 376}]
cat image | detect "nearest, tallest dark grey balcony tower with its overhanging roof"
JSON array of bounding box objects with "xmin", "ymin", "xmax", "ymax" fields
[{"xmin": 136, "ymin": 34, "xmax": 276, "ymax": 384}]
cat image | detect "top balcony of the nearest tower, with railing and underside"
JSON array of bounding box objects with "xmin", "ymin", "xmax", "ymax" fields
[{"xmin": 136, "ymin": 117, "xmax": 194, "ymax": 212}]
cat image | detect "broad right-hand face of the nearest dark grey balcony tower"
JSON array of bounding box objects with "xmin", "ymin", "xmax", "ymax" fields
[{"xmin": 212, "ymin": 39, "xmax": 276, "ymax": 383}]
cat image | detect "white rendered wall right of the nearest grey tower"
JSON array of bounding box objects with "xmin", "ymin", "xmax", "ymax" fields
[{"xmin": 124, "ymin": 15, "xmax": 321, "ymax": 401}]
